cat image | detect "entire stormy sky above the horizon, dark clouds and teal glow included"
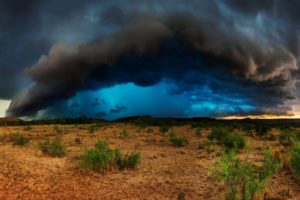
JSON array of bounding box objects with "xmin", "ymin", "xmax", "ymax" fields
[{"xmin": 0, "ymin": 0, "xmax": 300, "ymax": 119}]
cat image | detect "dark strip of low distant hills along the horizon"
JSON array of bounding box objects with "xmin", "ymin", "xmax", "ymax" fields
[{"xmin": 0, "ymin": 116, "xmax": 300, "ymax": 127}]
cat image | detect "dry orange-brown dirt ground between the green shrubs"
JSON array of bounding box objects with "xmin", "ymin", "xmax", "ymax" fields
[{"xmin": 0, "ymin": 124, "xmax": 300, "ymax": 200}]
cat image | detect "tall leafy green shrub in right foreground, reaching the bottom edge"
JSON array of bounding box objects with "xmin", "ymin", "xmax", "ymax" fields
[{"xmin": 211, "ymin": 151, "xmax": 282, "ymax": 200}]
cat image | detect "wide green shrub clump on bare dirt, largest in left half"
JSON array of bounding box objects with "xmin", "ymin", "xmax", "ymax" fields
[{"xmin": 79, "ymin": 140, "xmax": 141, "ymax": 172}]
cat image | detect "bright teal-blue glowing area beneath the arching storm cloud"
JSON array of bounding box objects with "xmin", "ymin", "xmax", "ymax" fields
[{"xmin": 41, "ymin": 80, "xmax": 255, "ymax": 120}]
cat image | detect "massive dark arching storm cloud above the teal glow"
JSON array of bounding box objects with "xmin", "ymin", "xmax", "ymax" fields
[{"xmin": 1, "ymin": 0, "xmax": 300, "ymax": 116}]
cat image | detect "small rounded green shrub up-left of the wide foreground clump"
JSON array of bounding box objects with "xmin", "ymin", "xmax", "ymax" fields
[{"xmin": 38, "ymin": 138, "xmax": 66, "ymax": 157}]
